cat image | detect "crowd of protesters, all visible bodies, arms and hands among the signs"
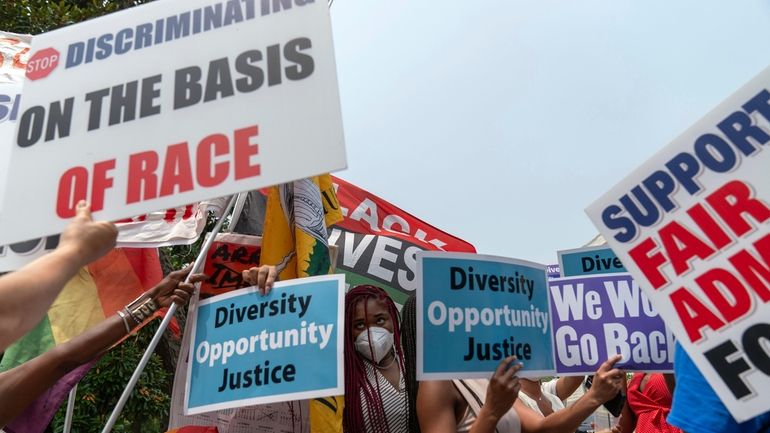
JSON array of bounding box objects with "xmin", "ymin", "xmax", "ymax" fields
[{"xmin": 0, "ymin": 203, "xmax": 770, "ymax": 433}]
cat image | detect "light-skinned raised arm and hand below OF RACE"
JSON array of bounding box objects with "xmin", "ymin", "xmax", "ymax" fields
[{"xmin": 0, "ymin": 202, "xmax": 118, "ymax": 352}]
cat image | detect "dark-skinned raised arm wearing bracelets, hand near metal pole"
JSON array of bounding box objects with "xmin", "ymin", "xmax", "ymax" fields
[{"xmin": 0, "ymin": 268, "xmax": 206, "ymax": 427}]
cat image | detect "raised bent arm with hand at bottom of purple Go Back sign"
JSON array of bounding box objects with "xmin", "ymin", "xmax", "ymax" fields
[{"xmin": 514, "ymin": 355, "xmax": 623, "ymax": 433}]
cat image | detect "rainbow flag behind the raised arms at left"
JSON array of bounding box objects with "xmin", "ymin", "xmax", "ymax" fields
[{"xmin": 0, "ymin": 248, "xmax": 163, "ymax": 433}]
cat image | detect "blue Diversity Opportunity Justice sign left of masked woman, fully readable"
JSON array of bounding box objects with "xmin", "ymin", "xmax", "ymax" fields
[{"xmin": 185, "ymin": 275, "xmax": 344, "ymax": 414}]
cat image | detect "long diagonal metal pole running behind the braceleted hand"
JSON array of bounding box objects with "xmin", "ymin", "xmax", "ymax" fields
[{"xmin": 102, "ymin": 195, "xmax": 237, "ymax": 433}]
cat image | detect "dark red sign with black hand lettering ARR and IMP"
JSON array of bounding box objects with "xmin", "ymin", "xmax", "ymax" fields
[{"xmin": 200, "ymin": 233, "xmax": 262, "ymax": 297}]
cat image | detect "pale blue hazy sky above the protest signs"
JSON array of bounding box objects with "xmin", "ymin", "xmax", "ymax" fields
[{"xmin": 331, "ymin": 0, "xmax": 770, "ymax": 263}]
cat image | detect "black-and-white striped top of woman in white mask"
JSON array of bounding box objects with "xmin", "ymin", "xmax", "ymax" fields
[{"xmin": 361, "ymin": 362, "xmax": 409, "ymax": 433}]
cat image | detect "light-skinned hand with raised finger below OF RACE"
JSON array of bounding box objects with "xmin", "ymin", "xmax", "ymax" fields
[{"xmin": 59, "ymin": 200, "xmax": 118, "ymax": 267}]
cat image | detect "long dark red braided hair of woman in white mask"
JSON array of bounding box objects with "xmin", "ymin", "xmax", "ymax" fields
[{"xmin": 342, "ymin": 285, "xmax": 405, "ymax": 433}]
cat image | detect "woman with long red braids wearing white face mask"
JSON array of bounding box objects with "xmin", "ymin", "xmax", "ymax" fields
[{"xmin": 343, "ymin": 285, "xmax": 409, "ymax": 433}]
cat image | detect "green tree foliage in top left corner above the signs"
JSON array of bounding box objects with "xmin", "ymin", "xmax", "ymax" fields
[{"xmin": 0, "ymin": 0, "xmax": 151, "ymax": 35}]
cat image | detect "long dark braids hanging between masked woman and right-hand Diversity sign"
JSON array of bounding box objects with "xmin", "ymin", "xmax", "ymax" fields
[{"xmin": 401, "ymin": 295, "xmax": 420, "ymax": 433}]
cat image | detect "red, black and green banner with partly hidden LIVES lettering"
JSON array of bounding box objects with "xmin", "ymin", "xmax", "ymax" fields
[{"xmin": 324, "ymin": 177, "xmax": 476, "ymax": 304}]
